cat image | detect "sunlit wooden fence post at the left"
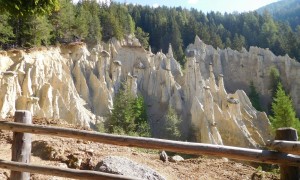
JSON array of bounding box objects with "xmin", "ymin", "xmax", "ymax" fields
[{"xmin": 10, "ymin": 110, "xmax": 32, "ymax": 180}]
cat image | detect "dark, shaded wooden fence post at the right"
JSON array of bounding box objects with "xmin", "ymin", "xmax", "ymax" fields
[{"xmin": 275, "ymin": 128, "xmax": 300, "ymax": 180}]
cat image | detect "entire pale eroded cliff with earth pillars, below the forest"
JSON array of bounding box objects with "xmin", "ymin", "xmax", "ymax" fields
[{"xmin": 0, "ymin": 37, "xmax": 300, "ymax": 148}]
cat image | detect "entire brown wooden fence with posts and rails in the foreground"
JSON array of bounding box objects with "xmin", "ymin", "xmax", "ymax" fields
[{"xmin": 0, "ymin": 111, "xmax": 300, "ymax": 180}]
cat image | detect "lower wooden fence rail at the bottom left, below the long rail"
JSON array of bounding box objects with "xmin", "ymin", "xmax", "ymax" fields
[{"xmin": 0, "ymin": 159, "xmax": 135, "ymax": 180}]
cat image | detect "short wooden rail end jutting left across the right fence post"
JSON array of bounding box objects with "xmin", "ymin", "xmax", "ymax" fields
[{"xmin": 267, "ymin": 140, "xmax": 300, "ymax": 155}]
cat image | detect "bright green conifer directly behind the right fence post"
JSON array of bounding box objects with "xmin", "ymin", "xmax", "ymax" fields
[{"xmin": 270, "ymin": 83, "xmax": 300, "ymax": 133}]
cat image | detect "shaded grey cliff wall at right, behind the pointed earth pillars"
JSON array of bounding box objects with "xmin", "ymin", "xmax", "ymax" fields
[{"xmin": 187, "ymin": 37, "xmax": 300, "ymax": 116}]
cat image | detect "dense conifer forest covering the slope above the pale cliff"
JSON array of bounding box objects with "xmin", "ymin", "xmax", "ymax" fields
[{"xmin": 0, "ymin": 0, "xmax": 300, "ymax": 64}]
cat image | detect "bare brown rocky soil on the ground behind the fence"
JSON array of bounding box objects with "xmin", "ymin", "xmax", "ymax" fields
[{"xmin": 0, "ymin": 118, "xmax": 278, "ymax": 180}]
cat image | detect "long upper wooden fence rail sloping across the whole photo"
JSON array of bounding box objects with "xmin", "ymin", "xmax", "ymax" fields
[{"xmin": 0, "ymin": 121, "xmax": 300, "ymax": 166}]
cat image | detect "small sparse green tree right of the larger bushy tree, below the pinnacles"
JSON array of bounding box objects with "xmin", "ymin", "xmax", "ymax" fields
[{"xmin": 163, "ymin": 106, "xmax": 182, "ymax": 140}]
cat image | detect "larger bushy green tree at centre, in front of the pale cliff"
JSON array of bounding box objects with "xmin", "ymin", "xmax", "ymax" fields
[{"xmin": 106, "ymin": 84, "xmax": 150, "ymax": 136}]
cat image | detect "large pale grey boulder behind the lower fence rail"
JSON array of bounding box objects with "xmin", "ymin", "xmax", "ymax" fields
[{"xmin": 94, "ymin": 156, "xmax": 165, "ymax": 180}]
